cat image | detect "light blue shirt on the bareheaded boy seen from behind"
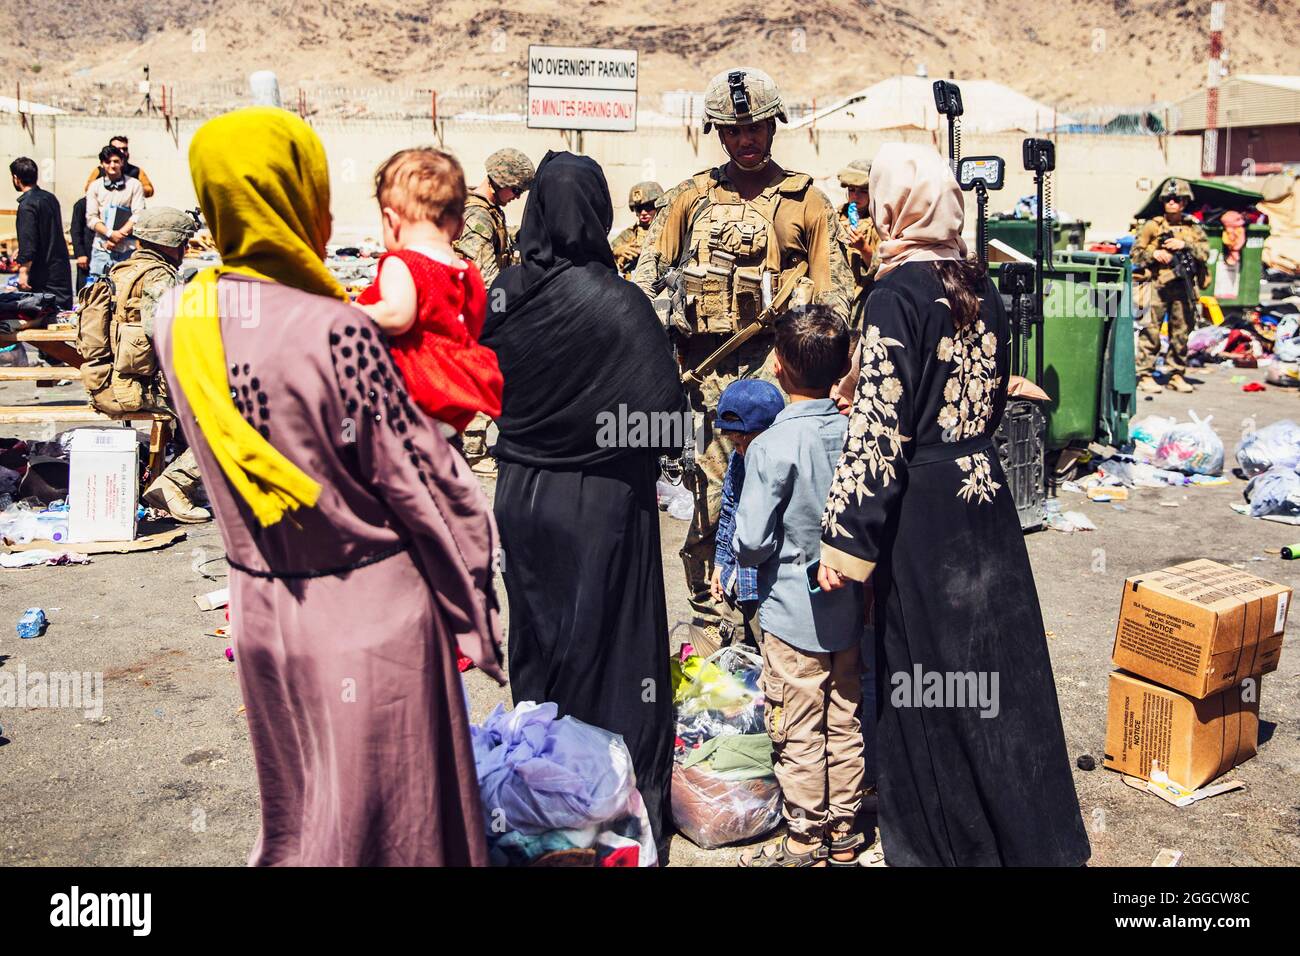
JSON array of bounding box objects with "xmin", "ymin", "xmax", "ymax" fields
[{"xmin": 735, "ymin": 398, "xmax": 865, "ymax": 653}]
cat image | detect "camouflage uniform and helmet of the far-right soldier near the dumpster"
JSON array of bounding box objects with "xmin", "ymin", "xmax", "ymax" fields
[{"xmin": 1132, "ymin": 179, "xmax": 1210, "ymax": 377}]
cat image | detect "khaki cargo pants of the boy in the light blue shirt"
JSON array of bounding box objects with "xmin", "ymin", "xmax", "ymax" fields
[{"xmin": 762, "ymin": 631, "xmax": 863, "ymax": 843}]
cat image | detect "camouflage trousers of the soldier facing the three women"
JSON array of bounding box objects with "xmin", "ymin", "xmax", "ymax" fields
[{"xmin": 680, "ymin": 333, "xmax": 779, "ymax": 627}]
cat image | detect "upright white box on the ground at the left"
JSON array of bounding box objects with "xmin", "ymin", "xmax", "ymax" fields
[{"xmin": 68, "ymin": 428, "xmax": 140, "ymax": 544}]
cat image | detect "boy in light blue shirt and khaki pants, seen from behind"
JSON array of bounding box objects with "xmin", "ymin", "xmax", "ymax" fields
[{"xmin": 735, "ymin": 306, "xmax": 865, "ymax": 866}]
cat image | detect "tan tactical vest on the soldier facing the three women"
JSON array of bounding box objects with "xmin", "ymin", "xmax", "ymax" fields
[{"xmin": 679, "ymin": 170, "xmax": 813, "ymax": 334}]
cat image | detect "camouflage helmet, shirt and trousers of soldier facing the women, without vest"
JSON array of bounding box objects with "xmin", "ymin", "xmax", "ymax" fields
[{"xmin": 633, "ymin": 69, "xmax": 853, "ymax": 641}]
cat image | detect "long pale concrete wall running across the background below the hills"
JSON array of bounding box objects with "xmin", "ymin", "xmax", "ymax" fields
[{"xmin": 0, "ymin": 114, "xmax": 1200, "ymax": 241}]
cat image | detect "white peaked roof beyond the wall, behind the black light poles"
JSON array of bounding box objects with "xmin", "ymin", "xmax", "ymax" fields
[{"xmin": 790, "ymin": 75, "xmax": 1071, "ymax": 133}]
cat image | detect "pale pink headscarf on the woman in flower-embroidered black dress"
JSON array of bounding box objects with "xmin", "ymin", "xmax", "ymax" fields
[{"xmin": 870, "ymin": 143, "xmax": 966, "ymax": 278}]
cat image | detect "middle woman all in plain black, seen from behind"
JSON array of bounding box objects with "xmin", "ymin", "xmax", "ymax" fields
[{"xmin": 482, "ymin": 152, "xmax": 689, "ymax": 860}]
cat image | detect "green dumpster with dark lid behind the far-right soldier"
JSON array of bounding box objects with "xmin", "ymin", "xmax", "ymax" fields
[{"xmin": 1138, "ymin": 177, "xmax": 1269, "ymax": 310}]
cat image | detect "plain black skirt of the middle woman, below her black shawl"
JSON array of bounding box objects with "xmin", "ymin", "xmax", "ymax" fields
[{"xmin": 495, "ymin": 454, "xmax": 673, "ymax": 847}]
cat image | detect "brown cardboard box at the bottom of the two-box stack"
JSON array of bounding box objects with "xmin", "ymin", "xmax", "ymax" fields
[{"xmin": 1102, "ymin": 671, "xmax": 1260, "ymax": 790}]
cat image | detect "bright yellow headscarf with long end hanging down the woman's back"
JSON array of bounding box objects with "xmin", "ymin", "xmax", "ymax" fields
[{"xmin": 172, "ymin": 107, "xmax": 347, "ymax": 527}]
